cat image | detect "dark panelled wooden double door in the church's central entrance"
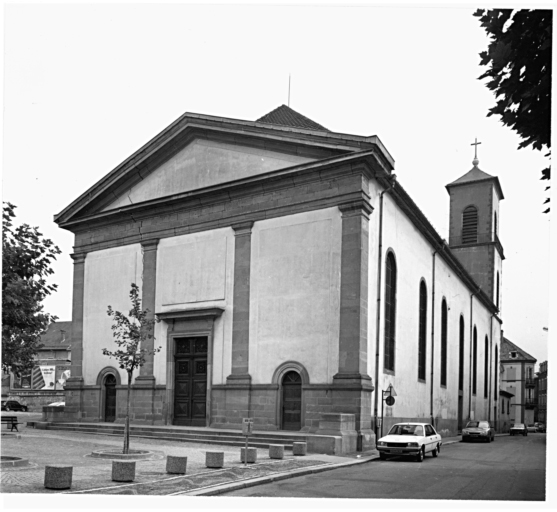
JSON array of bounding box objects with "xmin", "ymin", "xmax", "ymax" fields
[{"xmin": 173, "ymin": 336, "xmax": 209, "ymax": 427}]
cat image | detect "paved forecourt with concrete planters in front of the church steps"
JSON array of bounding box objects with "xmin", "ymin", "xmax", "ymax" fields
[{"xmin": 0, "ymin": 418, "xmax": 472, "ymax": 496}]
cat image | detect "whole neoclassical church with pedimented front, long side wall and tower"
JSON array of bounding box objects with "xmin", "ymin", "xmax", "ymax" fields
[{"xmin": 55, "ymin": 105, "xmax": 504, "ymax": 449}]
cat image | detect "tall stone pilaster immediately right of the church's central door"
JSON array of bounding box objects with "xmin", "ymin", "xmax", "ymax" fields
[{"xmin": 227, "ymin": 222, "xmax": 253, "ymax": 385}]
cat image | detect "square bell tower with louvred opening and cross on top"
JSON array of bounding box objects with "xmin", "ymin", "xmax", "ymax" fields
[{"xmin": 446, "ymin": 139, "xmax": 505, "ymax": 310}]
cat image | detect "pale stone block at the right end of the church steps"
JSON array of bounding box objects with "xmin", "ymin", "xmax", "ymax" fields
[{"xmin": 308, "ymin": 413, "xmax": 358, "ymax": 455}]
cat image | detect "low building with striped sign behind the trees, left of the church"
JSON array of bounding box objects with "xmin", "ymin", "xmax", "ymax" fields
[{"xmin": 9, "ymin": 322, "xmax": 72, "ymax": 410}]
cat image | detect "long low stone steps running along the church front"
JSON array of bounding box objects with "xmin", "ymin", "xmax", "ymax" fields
[{"xmin": 39, "ymin": 422, "xmax": 307, "ymax": 450}]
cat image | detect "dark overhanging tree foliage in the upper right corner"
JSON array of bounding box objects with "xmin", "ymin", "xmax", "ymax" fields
[{"xmin": 474, "ymin": 9, "xmax": 553, "ymax": 213}]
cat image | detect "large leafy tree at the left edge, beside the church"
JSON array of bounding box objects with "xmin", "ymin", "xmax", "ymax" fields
[{"xmin": 2, "ymin": 202, "xmax": 60, "ymax": 375}]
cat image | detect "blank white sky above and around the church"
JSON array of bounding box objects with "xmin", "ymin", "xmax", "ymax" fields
[{"xmin": 2, "ymin": 2, "xmax": 551, "ymax": 372}]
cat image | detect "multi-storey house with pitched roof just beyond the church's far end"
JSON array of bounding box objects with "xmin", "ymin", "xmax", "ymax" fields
[{"xmin": 501, "ymin": 338, "xmax": 537, "ymax": 425}]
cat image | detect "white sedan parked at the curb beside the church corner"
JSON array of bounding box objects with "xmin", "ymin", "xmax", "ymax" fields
[{"xmin": 377, "ymin": 423, "xmax": 443, "ymax": 462}]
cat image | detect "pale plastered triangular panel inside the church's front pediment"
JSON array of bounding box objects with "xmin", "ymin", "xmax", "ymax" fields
[{"xmin": 102, "ymin": 139, "xmax": 314, "ymax": 211}]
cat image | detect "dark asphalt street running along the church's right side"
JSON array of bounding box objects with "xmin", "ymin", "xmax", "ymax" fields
[{"xmin": 223, "ymin": 434, "xmax": 546, "ymax": 501}]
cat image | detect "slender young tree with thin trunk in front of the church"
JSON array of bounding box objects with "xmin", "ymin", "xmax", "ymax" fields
[{"xmin": 102, "ymin": 283, "xmax": 161, "ymax": 453}]
